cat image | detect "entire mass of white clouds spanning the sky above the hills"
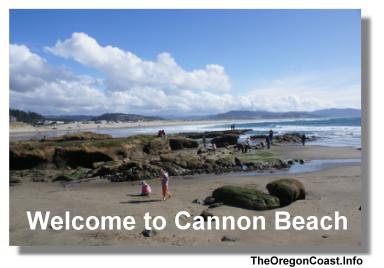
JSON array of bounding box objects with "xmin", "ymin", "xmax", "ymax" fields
[{"xmin": 10, "ymin": 33, "xmax": 360, "ymax": 116}]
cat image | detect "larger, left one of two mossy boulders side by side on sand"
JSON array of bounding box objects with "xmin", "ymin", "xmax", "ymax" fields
[{"xmin": 212, "ymin": 185, "xmax": 280, "ymax": 210}]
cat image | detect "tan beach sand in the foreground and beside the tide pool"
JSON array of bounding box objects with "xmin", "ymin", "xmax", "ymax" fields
[{"xmin": 10, "ymin": 145, "xmax": 364, "ymax": 250}]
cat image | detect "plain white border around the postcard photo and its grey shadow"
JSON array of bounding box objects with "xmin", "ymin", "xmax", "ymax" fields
[{"xmin": 0, "ymin": 0, "xmax": 384, "ymax": 268}]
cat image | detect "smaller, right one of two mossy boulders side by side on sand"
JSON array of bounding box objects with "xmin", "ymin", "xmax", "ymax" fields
[{"xmin": 266, "ymin": 178, "xmax": 305, "ymax": 206}]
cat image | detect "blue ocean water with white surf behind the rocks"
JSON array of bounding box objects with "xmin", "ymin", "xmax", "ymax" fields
[{"xmin": 11, "ymin": 117, "xmax": 361, "ymax": 147}]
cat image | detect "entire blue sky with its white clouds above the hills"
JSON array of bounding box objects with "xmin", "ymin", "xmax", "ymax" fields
[{"xmin": 9, "ymin": 10, "xmax": 361, "ymax": 116}]
